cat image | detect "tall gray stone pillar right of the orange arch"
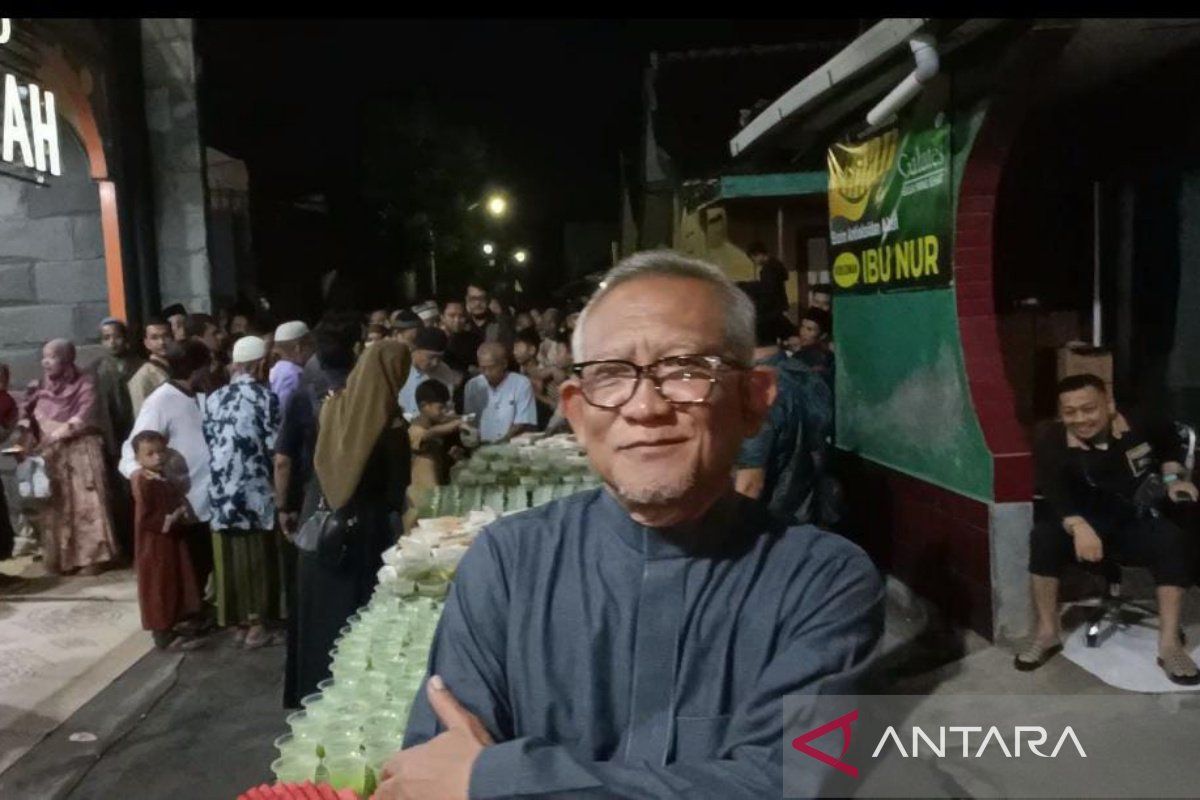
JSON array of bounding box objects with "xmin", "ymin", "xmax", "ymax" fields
[{"xmin": 142, "ymin": 19, "xmax": 211, "ymax": 312}]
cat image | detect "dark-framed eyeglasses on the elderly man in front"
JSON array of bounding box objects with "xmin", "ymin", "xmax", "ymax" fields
[{"xmin": 571, "ymin": 355, "xmax": 745, "ymax": 409}]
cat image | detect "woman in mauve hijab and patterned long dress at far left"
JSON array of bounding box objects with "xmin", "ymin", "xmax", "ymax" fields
[{"xmin": 20, "ymin": 339, "xmax": 118, "ymax": 575}]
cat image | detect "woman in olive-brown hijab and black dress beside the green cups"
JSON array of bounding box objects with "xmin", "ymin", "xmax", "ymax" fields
[{"xmin": 295, "ymin": 341, "xmax": 409, "ymax": 697}]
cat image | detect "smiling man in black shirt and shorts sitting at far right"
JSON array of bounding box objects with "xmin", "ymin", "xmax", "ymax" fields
[{"xmin": 1015, "ymin": 375, "xmax": 1200, "ymax": 685}]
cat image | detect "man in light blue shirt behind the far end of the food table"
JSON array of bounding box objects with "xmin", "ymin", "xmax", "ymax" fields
[{"xmin": 463, "ymin": 342, "xmax": 538, "ymax": 444}]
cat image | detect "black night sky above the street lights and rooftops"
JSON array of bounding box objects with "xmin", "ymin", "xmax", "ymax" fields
[{"xmin": 197, "ymin": 20, "xmax": 858, "ymax": 298}]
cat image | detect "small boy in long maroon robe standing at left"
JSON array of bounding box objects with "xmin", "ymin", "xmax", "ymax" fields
[{"xmin": 130, "ymin": 431, "xmax": 202, "ymax": 650}]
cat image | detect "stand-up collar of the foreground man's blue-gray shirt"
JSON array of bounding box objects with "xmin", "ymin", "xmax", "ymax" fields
[{"xmin": 595, "ymin": 488, "xmax": 756, "ymax": 560}]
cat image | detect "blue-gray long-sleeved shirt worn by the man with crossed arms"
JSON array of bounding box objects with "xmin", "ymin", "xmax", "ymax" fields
[{"xmin": 404, "ymin": 489, "xmax": 883, "ymax": 800}]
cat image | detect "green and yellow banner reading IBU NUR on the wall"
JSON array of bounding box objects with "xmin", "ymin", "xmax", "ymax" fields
[{"xmin": 828, "ymin": 118, "xmax": 953, "ymax": 293}]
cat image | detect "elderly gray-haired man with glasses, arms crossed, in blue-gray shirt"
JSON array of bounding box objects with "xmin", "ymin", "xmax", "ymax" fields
[{"xmin": 376, "ymin": 252, "xmax": 883, "ymax": 800}]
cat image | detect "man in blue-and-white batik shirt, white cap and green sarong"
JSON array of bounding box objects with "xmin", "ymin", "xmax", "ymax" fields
[{"xmin": 204, "ymin": 336, "xmax": 281, "ymax": 649}]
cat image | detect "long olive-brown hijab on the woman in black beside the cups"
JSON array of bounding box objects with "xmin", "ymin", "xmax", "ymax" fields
[{"xmin": 313, "ymin": 341, "xmax": 410, "ymax": 509}]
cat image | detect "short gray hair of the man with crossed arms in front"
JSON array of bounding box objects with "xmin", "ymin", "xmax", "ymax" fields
[{"xmin": 571, "ymin": 249, "xmax": 755, "ymax": 365}]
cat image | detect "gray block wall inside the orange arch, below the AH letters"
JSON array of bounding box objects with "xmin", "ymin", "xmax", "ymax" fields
[{"xmin": 0, "ymin": 130, "xmax": 108, "ymax": 389}]
